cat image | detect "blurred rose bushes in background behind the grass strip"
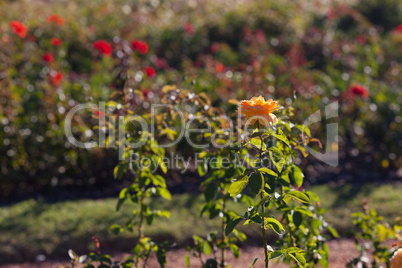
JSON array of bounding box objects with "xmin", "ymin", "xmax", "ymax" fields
[{"xmin": 0, "ymin": 0, "xmax": 402, "ymax": 197}]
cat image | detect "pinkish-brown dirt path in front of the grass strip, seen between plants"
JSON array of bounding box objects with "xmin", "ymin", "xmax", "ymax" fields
[{"xmin": 1, "ymin": 239, "xmax": 358, "ymax": 268}]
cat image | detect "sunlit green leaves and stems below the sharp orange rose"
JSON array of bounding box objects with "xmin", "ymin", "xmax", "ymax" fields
[{"xmin": 225, "ymin": 114, "xmax": 337, "ymax": 267}]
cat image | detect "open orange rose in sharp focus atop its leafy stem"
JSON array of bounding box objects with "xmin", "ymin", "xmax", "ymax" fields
[{"xmin": 240, "ymin": 96, "xmax": 279, "ymax": 126}]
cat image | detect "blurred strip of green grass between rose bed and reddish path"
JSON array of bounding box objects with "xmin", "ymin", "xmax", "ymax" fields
[{"xmin": 0, "ymin": 184, "xmax": 402, "ymax": 262}]
